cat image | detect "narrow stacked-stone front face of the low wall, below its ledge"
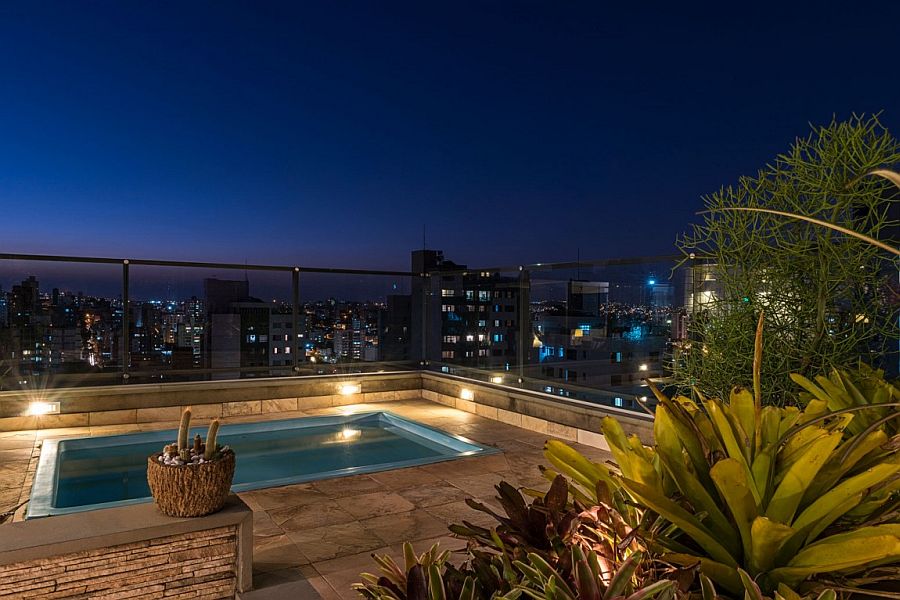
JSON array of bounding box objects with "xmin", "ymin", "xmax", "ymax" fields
[{"xmin": 0, "ymin": 526, "xmax": 238, "ymax": 600}]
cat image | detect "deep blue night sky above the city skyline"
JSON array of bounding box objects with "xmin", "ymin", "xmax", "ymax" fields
[{"xmin": 0, "ymin": 1, "xmax": 900, "ymax": 269}]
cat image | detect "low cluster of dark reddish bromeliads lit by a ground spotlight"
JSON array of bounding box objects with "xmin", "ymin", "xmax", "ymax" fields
[{"xmin": 354, "ymin": 475, "xmax": 678, "ymax": 600}]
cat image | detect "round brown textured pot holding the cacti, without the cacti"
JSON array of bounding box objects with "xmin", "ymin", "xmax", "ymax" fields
[{"xmin": 147, "ymin": 450, "xmax": 235, "ymax": 517}]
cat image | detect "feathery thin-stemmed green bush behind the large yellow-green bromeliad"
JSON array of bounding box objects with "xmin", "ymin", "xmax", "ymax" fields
[{"xmin": 673, "ymin": 117, "xmax": 900, "ymax": 404}]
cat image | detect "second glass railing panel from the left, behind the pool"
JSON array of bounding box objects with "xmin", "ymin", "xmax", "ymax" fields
[{"xmin": 122, "ymin": 264, "xmax": 293, "ymax": 383}]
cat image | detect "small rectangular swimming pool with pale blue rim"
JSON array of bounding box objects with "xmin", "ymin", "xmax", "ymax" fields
[{"xmin": 27, "ymin": 412, "xmax": 497, "ymax": 518}]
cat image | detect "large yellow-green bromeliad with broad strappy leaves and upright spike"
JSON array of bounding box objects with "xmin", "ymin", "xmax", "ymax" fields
[{"xmin": 603, "ymin": 315, "xmax": 900, "ymax": 598}]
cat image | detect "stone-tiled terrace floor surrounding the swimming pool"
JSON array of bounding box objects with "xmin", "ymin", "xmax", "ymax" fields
[{"xmin": 0, "ymin": 400, "xmax": 610, "ymax": 600}]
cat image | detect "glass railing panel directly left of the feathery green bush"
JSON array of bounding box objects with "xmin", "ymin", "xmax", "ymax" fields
[{"xmin": 525, "ymin": 259, "xmax": 685, "ymax": 409}]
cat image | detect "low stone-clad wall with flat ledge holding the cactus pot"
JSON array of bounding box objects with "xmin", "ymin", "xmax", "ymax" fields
[{"xmin": 0, "ymin": 495, "xmax": 253, "ymax": 599}]
